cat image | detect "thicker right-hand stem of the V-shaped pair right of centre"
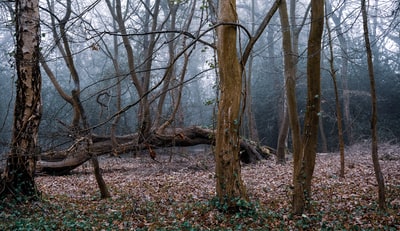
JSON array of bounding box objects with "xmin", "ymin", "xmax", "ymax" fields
[{"xmin": 293, "ymin": 0, "xmax": 324, "ymax": 214}]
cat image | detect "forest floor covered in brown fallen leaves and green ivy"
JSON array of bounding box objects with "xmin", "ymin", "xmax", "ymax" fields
[{"xmin": 0, "ymin": 143, "xmax": 400, "ymax": 230}]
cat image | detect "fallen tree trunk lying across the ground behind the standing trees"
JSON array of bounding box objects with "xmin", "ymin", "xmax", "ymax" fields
[{"xmin": 37, "ymin": 126, "xmax": 275, "ymax": 175}]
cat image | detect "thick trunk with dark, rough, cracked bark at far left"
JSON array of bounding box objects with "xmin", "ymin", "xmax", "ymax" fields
[{"xmin": 0, "ymin": 0, "xmax": 42, "ymax": 199}]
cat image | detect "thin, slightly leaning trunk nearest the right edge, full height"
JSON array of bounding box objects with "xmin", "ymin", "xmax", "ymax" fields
[{"xmin": 361, "ymin": 0, "xmax": 386, "ymax": 211}]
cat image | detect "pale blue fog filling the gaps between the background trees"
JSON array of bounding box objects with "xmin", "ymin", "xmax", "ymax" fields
[{"xmin": 0, "ymin": 1, "xmax": 400, "ymax": 155}]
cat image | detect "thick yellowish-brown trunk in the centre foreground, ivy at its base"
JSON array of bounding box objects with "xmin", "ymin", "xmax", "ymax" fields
[{"xmin": 215, "ymin": 0, "xmax": 248, "ymax": 210}]
